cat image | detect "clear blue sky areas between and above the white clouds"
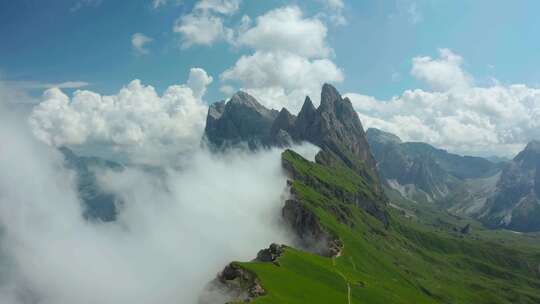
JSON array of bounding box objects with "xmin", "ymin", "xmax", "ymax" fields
[{"xmin": 4, "ymin": 0, "xmax": 540, "ymax": 101}]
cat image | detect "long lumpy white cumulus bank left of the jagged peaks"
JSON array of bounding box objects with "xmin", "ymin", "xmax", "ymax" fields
[{"xmin": 29, "ymin": 68, "xmax": 212, "ymax": 163}]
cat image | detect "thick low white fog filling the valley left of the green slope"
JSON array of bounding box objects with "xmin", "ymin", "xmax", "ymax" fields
[{"xmin": 0, "ymin": 98, "xmax": 300, "ymax": 304}]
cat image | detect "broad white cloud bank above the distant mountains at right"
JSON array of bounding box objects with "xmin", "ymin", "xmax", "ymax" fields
[{"xmin": 347, "ymin": 49, "xmax": 540, "ymax": 156}]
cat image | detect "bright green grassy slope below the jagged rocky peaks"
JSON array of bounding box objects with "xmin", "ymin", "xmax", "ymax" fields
[{"xmin": 234, "ymin": 151, "xmax": 540, "ymax": 304}]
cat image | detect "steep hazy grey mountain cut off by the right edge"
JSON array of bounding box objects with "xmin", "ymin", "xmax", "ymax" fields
[{"xmin": 479, "ymin": 141, "xmax": 540, "ymax": 232}]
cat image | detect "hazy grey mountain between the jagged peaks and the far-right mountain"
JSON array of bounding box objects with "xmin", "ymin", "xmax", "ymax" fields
[{"xmin": 367, "ymin": 128, "xmax": 501, "ymax": 202}]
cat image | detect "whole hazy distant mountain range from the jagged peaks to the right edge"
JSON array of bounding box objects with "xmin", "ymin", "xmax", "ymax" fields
[{"xmin": 367, "ymin": 129, "xmax": 540, "ymax": 232}]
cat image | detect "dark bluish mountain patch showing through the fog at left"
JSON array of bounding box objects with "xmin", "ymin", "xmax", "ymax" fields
[{"xmin": 59, "ymin": 147, "xmax": 123, "ymax": 222}]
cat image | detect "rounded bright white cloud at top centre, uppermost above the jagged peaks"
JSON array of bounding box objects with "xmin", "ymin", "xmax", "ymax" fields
[{"xmin": 238, "ymin": 6, "xmax": 331, "ymax": 58}]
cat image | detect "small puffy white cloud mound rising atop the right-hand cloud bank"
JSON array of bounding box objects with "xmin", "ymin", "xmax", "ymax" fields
[{"xmin": 411, "ymin": 49, "xmax": 472, "ymax": 92}]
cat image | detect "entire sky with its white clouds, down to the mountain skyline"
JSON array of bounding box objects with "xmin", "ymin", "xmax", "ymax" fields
[{"xmin": 0, "ymin": 0, "xmax": 540, "ymax": 156}]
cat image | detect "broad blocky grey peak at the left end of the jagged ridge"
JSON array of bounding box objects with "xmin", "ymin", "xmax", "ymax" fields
[{"xmin": 205, "ymin": 92, "xmax": 278, "ymax": 149}]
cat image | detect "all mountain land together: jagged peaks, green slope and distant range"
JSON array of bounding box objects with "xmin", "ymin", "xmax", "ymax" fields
[{"xmin": 200, "ymin": 85, "xmax": 540, "ymax": 304}]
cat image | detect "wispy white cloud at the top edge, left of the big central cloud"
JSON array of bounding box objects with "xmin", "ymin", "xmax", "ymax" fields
[{"xmin": 173, "ymin": 0, "xmax": 240, "ymax": 48}]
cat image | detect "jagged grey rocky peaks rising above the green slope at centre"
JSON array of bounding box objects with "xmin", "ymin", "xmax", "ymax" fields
[{"xmin": 204, "ymin": 84, "xmax": 382, "ymax": 193}]
